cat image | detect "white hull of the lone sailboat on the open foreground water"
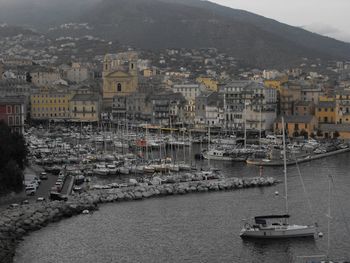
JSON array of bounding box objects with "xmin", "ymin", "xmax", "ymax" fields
[{"xmin": 240, "ymin": 225, "xmax": 316, "ymax": 239}]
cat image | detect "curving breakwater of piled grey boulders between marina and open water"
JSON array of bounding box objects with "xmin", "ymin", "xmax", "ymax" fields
[{"xmin": 0, "ymin": 177, "xmax": 278, "ymax": 263}]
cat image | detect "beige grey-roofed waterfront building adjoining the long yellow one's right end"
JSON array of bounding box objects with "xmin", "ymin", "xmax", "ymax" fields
[{"xmin": 69, "ymin": 93, "xmax": 100, "ymax": 122}]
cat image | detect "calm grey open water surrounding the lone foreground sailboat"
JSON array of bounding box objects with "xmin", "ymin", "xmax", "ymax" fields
[{"xmin": 15, "ymin": 154, "xmax": 350, "ymax": 263}]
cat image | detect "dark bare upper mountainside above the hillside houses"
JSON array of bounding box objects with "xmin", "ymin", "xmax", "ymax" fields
[{"xmin": 0, "ymin": 0, "xmax": 350, "ymax": 67}]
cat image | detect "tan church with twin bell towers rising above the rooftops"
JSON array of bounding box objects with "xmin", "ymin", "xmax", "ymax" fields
[{"xmin": 102, "ymin": 52, "xmax": 138, "ymax": 110}]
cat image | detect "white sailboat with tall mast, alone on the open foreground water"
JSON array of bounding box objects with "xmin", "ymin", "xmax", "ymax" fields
[{"xmin": 240, "ymin": 117, "xmax": 316, "ymax": 239}]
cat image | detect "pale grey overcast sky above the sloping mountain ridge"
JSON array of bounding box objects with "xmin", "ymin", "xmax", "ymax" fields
[{"xmin": 210, "ymin": 0, "xmax": 350, "ymax": 42}]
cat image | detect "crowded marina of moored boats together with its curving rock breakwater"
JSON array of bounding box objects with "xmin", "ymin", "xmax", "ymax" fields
[{"xmin": 0, "ymin": 124, "xmax": 349, "ymax": 262}]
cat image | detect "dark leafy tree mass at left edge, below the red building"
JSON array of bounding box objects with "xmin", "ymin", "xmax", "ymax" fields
[{"xmin": 0, "ymin": 122, "xmax": 28, "ymax": 193}]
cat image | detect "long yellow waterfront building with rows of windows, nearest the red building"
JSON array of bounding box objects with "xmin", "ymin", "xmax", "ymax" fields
[{"xmin": 30, "ymin": 88, "xmax": 73, "ymax": 120}]
